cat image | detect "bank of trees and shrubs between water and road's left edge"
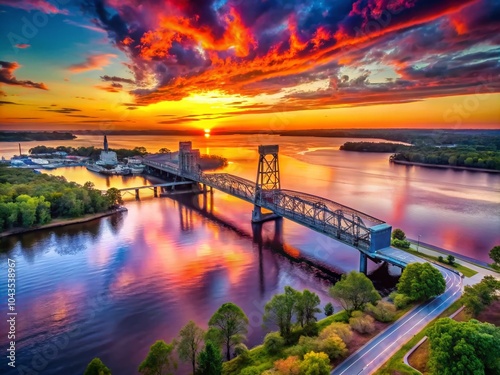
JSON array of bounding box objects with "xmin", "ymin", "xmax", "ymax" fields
[{"xmin": 84, "ymin": 264, "xmax": 444, "ymax": 375}]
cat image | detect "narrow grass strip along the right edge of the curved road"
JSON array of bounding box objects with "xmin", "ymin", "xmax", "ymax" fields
[{"xmin": 375, "ymin": 298, "xmax": 462, "ymax": 375}]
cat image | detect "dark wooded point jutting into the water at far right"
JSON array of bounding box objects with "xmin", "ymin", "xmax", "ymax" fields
[{"xmin": 391, "ymin": 146, "xmax": 500, "ymax": 170}]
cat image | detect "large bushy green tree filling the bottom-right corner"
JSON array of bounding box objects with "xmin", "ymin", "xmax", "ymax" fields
[{"xmin": 427, "ymin": 318, "xmax": 500, "ymax": 375}]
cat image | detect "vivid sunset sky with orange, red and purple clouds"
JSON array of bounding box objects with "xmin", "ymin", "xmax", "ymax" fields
[{"xmin": 0, "ymin": 0, "xmax": 500, "ymax": 131}]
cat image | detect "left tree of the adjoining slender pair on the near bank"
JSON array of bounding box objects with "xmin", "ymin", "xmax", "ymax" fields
[{"xmin": 263, "ymin": 286, "xmax": 299, "ymax": 340}]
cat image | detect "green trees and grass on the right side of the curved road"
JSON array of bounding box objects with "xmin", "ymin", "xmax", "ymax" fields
[{"xmin": 376, "ymin": 276, "xmax": 500, "ymax": 375}]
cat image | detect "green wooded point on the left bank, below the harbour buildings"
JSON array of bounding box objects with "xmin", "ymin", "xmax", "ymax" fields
[{"xmin": 0, "ymin": 166, "xmax": 123, "ymax": 232}]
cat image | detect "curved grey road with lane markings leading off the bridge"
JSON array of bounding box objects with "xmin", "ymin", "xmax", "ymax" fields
[{"xmin": 331, "ymin": 258, "xmax": 462, "ymax": 375}]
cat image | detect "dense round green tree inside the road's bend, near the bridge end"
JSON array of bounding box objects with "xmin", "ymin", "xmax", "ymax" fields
[{"xmin": 397, "ymin": 263, "xmax": 446, "ymax": 301}]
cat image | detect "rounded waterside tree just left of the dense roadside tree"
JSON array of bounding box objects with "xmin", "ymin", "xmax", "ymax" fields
[{"xmin": 330, "ymin": 271, "xmax": 381, "ymax": 315}]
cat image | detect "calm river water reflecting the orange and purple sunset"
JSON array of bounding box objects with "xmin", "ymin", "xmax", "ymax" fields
[{"xmin": 0, "ymin": 136, "xmax": 500, "ymax": 375}]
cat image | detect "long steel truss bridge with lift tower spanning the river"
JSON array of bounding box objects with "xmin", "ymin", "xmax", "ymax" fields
[{"xmin": 143, "ymin": 146, "xmax": 407, "ymax": 273}]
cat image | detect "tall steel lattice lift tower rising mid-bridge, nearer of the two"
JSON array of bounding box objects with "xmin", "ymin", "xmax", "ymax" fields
[{"xmin": 252, "ymin": 145, "xmax": 281, "ymax": 223}]
